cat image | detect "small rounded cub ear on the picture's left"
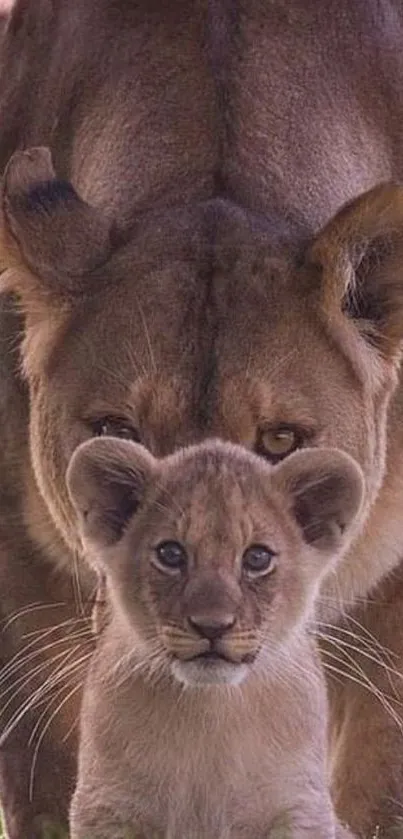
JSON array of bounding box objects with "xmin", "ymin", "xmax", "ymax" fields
[{"xmin": 66, "ymin": 437, "xmax": 157, "ymax": 548}]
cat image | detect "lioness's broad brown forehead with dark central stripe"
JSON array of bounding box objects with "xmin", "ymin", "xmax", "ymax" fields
[{"xmin": 53, "ymin": 199, "xmax": 362, "ymax": 454}]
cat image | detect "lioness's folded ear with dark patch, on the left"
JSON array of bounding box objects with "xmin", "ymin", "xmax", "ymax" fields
[{"xmin": 0, "ymin": 148, "xmax": 113, "ymax": 307}]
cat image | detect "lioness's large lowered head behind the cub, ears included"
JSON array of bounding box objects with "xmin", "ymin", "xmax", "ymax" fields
[{"xmin": 0, "ymin": 149, "xmax": 403, "ymax": 612}]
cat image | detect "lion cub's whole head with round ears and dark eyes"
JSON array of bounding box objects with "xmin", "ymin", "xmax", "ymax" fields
[{"xmin": 67, "ymin": 438, "xmax": 363, "ymax": 684}]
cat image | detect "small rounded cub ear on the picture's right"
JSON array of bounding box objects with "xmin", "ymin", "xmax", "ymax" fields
[{"xmin": 273, "ymin": 449, "xmax": 364, "ymax": 553}]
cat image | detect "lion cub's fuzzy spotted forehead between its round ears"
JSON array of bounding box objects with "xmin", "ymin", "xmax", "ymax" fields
[{"xmin": 132, "ymin": 440, "xmax": 295, "ymax": 567}]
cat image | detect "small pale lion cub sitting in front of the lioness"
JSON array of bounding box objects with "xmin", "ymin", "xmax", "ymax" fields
[{"xmin": 67, "ymin": 438, "xmax": 363, "ymax": 839}]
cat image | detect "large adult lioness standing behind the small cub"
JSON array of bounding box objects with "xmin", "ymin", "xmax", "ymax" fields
[{"xmin": 0, "ymin": 0, "xmax": 403, "ymax": 839}]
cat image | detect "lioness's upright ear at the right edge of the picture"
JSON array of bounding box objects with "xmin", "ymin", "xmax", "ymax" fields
[{"xmin": 308, "ymin": 184, "xmax": 403, "ymax": 359}]
